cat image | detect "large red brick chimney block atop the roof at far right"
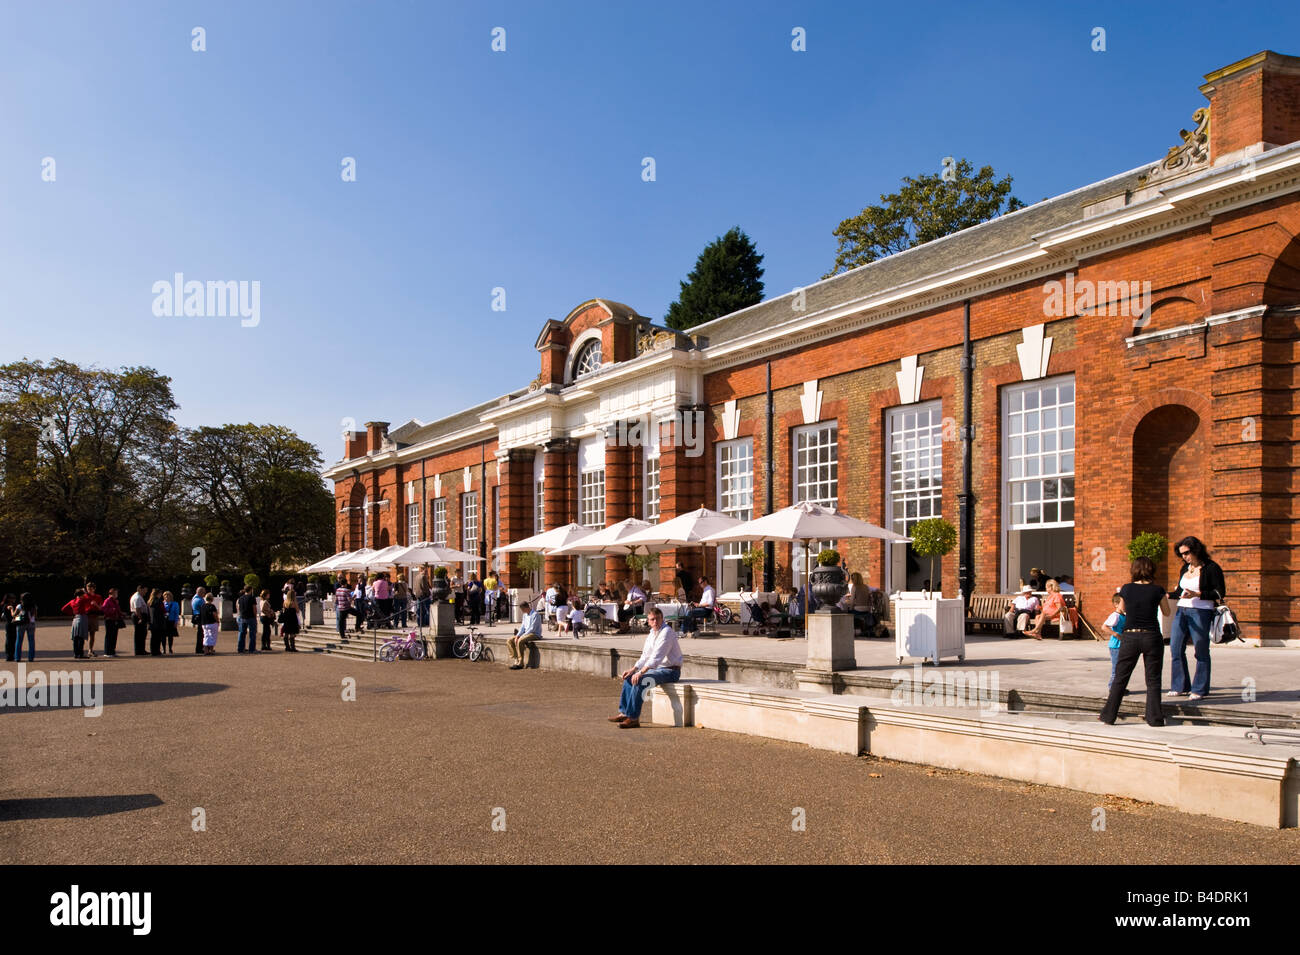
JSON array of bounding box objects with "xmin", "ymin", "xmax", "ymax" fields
[{"xmin": 1201, "ymin": 49, "xmax": 1300, "ymax": 165}]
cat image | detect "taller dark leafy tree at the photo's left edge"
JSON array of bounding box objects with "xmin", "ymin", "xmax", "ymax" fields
[{"xmin": 0, "ymin": 359, "xmax": 185, "ymax": 574}]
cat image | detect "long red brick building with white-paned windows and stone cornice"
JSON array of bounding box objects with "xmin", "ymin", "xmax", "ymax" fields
[{"xmin": 326, "ymin": 52, "xmax": 1300, "ymax": 638}]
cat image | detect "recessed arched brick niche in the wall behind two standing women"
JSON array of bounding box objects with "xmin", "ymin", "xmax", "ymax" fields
[{"xmin": 1131, "ymin": 404, "xmax": 1209, "ymax": 571}]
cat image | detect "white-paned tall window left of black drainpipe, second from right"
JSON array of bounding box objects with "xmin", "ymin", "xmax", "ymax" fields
[{"xmin": 889, "ymin": 401, "xmax": 944, "ymax": 535}]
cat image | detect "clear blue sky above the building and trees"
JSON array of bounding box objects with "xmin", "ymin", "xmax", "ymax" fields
[{"xmin": 0, "ymin": 0, "xmax": 1300, "ymax": 461}]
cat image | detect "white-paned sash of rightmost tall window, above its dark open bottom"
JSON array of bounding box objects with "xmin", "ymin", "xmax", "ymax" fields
[{"xmin": 1005, "ymin": 379, "xmax": 1074, "ymax": 530}]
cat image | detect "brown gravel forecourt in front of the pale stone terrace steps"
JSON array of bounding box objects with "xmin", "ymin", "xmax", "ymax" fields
[{"xmin": 0, "ymin": 634, "xmax": 1300, "ymax": 864}]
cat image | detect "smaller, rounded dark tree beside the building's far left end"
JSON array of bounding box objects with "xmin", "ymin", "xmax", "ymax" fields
[{"xmin": 185, "ymin": 424, "xmax": 334, "ymax": 578}]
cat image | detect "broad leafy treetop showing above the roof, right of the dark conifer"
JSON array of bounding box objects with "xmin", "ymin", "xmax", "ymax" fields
[{"xmin": 822, "ymin": 159, "xmax": 1024, "ymax": 278}]
